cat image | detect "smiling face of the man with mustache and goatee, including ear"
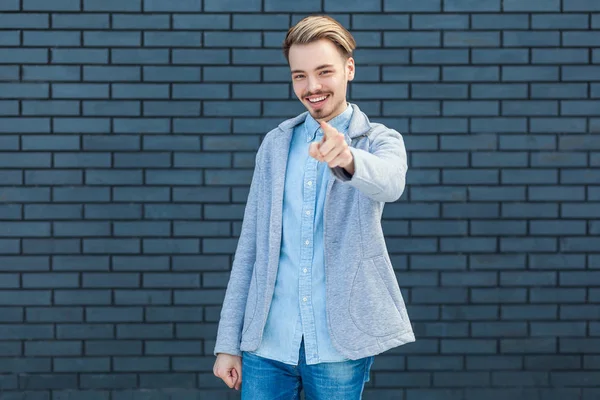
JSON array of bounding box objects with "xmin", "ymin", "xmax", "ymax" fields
[{"xmin": 289, "ymin": 39, "xmax": 354, "ymax": 121}]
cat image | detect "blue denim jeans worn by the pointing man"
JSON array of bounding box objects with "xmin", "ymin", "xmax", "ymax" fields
[{"xmin": 242, "ymin": 343, "xmax": 374, "ymax": 400}]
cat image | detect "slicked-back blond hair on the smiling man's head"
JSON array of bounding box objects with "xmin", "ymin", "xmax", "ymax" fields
[{"xmin": 283, "ymin": 15, "xmax": 356, "ymax": 62}]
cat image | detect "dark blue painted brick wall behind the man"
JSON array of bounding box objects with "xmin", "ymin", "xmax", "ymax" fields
[{"xmin": 0, "ymin": 0, "xmax": 600, "ymax": 400}]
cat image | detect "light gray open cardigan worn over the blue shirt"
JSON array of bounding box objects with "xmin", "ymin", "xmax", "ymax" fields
[{"xmin": 214, "ymin": 104, "xmax": 415, "ymax": 359}]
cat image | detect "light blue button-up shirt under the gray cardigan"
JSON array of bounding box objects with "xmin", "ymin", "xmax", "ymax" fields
[{"xmin": 253, "ymin": 105, "xmax": 353, "ymax": 365}]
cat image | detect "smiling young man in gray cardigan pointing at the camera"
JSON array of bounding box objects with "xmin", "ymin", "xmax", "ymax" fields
[{"xmin": 214, "ymin": 16, "xmax": 415, "ymax": 400}]
